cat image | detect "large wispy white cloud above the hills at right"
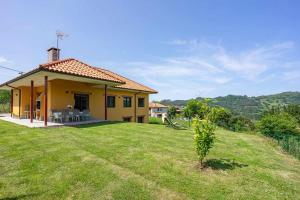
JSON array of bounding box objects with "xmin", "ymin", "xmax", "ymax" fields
[{"xmin": 102, "ymin": 39, "xmax": 298, "ymax": 99}]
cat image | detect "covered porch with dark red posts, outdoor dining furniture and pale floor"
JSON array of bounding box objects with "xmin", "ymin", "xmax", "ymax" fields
[{"xmin": 1, "ymin": 71, "xmax": 118, "ymax": 127}]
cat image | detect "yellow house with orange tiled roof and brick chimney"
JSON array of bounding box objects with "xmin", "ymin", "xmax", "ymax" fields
[{"xmin": 0, "ymin": 48, "xmax": 157, "ymax": 126}]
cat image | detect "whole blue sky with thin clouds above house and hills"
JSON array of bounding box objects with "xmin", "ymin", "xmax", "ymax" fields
[{"xmin": 0, "ymin": 0, "xmax": 300, "ymax": 100}]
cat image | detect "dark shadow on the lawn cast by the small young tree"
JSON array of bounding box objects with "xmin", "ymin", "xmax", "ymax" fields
[{"xmin": 204, "ymin": 159, "xmax": 248, "ymax": 170}]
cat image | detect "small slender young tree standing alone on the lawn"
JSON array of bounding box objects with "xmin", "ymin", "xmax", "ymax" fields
[{"xmin": 193, "ymin": 117, "xmax": 215, "ymax": 168}]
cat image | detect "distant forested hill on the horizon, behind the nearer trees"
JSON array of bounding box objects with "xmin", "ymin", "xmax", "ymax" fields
[{"xmin": 160, "ymin": 92, "xmax": 300, "ymax": 119}]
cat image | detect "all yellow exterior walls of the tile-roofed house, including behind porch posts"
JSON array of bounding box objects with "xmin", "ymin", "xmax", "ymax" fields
[{"xmin": 14, "ymin": 79, "xmax": 149, "ymax": 122}]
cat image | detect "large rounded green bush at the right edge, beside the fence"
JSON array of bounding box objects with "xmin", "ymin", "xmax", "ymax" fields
[{"xmin": 258, "ymin": 112, "xmax": 297, "ymax": 139}]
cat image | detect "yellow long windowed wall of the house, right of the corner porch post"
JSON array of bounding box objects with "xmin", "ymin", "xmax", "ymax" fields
[{"xmin": 49, "ymin": 80, "xmax": 149, "ymax": 122}]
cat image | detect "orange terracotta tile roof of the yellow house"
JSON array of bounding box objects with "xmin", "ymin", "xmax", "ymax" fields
[{"xmin": 40, "ymin": 58, "xmax": 157, "ymax": 93}]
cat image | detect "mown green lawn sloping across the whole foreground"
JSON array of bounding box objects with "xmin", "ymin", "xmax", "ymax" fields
[{"xmin": 0, "ymin": 121, "xmax": 300, "ymax": 200}]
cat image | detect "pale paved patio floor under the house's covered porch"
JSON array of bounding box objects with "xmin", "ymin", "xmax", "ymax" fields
[{"xmin": 0, "ymin": 114, "xmax": 104, "ymax": 128}]
